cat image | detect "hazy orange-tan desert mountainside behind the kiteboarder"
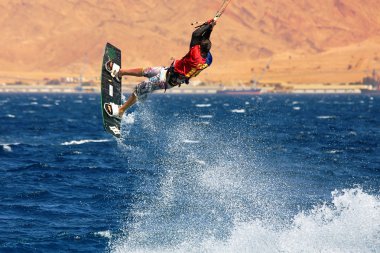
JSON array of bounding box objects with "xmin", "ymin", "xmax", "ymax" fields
[{"xmin": 0, "ymin": 0, "xmax": 380, "ymax": 83}]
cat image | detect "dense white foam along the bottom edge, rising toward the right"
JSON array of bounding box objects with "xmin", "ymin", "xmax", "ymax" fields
[{"xmin": 111, "ymin": 188, "xmax": 380, "ymax": 253}]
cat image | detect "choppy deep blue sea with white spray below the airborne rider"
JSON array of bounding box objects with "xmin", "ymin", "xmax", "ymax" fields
[{"xmin": 0, "ymin": 94, "xmax": 380, "ymax": 252}]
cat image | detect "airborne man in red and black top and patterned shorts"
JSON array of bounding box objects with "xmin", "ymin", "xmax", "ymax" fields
[{"xmin": 104, "ymin": 19, "xmax": 216, "ymax": 118}]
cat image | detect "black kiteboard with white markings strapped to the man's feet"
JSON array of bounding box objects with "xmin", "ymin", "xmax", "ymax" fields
[{"xmin": 100, "ymin": 43, "xmax": 121, "ymax": 138}]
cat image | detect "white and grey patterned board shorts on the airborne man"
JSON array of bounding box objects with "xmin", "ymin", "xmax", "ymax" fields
[{"xmin": 133, "ymin": 67, "xmax": 174, "ymax": 101}]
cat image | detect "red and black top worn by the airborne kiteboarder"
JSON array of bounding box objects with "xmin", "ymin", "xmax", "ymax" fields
[{"xmin": 174, "ymin": 24, "xmax": 213, "ymax": 79}]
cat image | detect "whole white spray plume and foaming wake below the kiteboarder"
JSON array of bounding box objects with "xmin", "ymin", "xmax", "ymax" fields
[{"xmin": 109, "ymin": 99, "xmax": 380, "ymax": 253}]
